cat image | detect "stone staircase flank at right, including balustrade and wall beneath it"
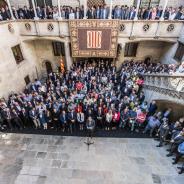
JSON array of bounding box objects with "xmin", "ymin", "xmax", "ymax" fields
[{"xmin": 144, "ymin": 74, "xmax": 184, "ymax": 104}]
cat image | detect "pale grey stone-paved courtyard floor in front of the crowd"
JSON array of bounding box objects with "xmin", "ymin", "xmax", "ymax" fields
[{"xmin": 0, "ymin": 134, "xmax": 184, "ymax": 184}]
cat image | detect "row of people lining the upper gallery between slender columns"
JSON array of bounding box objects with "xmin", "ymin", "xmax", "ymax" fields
[{"xmin": 0, "ymin": 5, "xmax": 184, "ymax": 20}]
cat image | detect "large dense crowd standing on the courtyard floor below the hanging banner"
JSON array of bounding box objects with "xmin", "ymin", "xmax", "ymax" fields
[{"xmin": 0, "ymin": 59, "xmax": 184, "ymax": 173}]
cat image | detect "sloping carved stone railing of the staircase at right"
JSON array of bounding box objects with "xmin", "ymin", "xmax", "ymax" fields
[{"xmin": 144, "ymin": 74, "xmax": 184, "ymax": 100}]
